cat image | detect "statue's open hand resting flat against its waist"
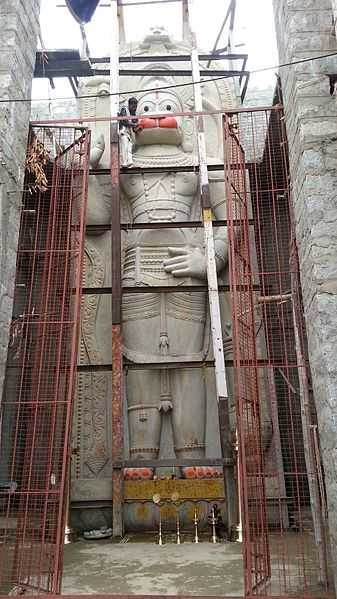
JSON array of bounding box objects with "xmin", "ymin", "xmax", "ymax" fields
[{"xmin": 164, "ymin": 247, "xmax": 206, "ymax": 279}]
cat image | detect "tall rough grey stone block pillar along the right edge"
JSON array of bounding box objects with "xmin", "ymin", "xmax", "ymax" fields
[{"xmin": 273, "ymin": 0, "xmax": 337, "ymax": 587}]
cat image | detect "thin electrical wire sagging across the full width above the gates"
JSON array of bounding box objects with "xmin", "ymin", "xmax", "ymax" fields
[{"xmin": 0, "ymin": 52, "xmax": 337, "ymax": 104}]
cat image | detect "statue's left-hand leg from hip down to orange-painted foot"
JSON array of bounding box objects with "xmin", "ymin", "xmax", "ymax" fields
[{"xmin": 122, "ymin": 294, "xmax": 161, "ymax": 478}]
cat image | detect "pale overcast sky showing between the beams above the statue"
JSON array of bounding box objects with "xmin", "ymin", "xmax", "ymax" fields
[{"xmin": 33, "ymin": 0, "xmax": 278, "ymax": 98}]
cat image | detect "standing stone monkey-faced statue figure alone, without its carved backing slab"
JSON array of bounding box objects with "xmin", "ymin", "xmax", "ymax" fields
[{"xmin": 117, "ymin": 90, "xmax": 227, "ymax": 477}]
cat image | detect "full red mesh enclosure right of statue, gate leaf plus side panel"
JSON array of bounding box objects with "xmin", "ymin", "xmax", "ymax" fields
[{"xmin": 224, "ymin": 108, "xmax": 329, "ymax": 597}]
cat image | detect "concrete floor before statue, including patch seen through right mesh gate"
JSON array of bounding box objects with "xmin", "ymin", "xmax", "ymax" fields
[{"xmin": 62, "ymin": 532, "xmax": 327, "ymax": 599}]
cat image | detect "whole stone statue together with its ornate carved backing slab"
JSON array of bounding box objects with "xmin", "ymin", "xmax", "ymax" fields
[{"xmin": 72, "ymin": 28, "xmax": 284, "ymax": 527}]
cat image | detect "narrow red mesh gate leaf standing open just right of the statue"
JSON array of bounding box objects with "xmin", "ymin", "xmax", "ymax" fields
[{"xmin": 224, "ymin": 116, "xmax": 270, "ymax": 594}]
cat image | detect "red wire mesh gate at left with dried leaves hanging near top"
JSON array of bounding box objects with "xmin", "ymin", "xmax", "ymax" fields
[{"xmin": 0, "ymin": 127, "xmax": 90, "ymax": 594}]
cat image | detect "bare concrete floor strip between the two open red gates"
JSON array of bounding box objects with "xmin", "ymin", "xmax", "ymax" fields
[{"xmin": 62, "ymin": 539, "xmax": 243, "ymax": 597}]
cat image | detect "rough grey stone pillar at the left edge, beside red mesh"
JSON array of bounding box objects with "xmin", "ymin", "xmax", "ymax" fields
[{"xmin": 0, "ymin": 0, "xmax": 40, "ymax": 398}]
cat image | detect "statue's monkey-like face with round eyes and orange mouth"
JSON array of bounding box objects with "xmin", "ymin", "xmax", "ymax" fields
[{"xmin": 137, "ymin": 90, "xmax": 182, "ymax": 146}]
